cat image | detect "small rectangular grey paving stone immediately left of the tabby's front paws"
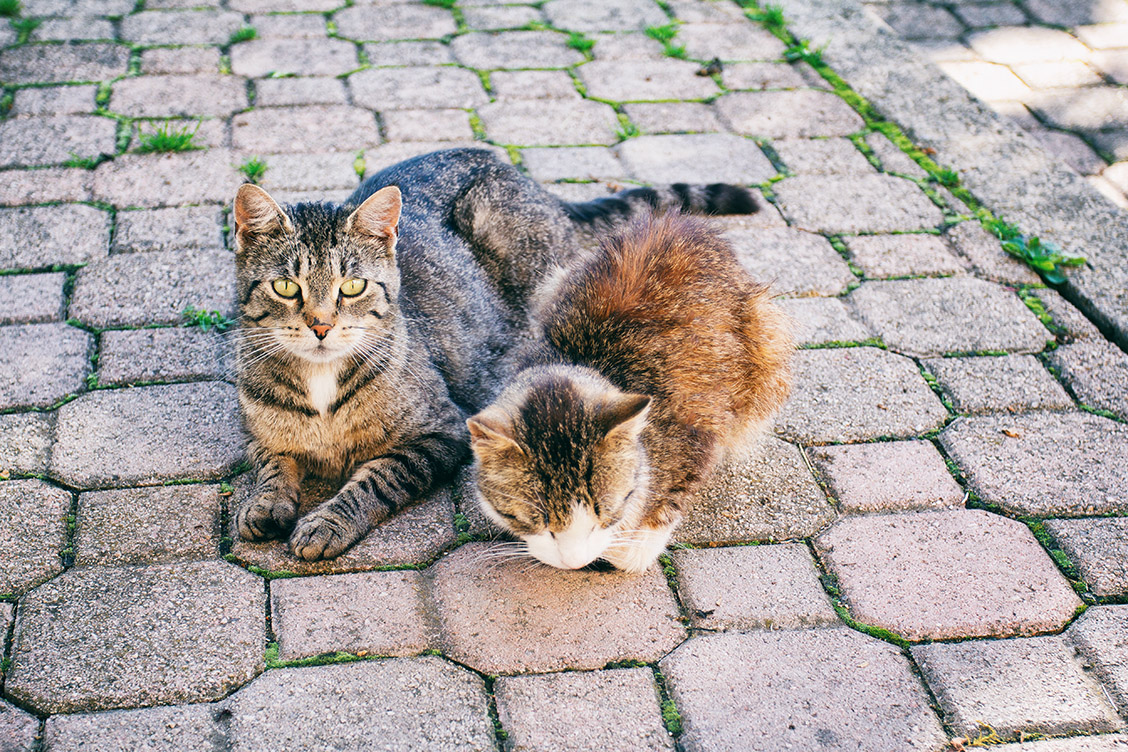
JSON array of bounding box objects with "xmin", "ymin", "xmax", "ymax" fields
[{"xmin": 74, "ymin": 484, "xmax": 220, "ymax": 566}]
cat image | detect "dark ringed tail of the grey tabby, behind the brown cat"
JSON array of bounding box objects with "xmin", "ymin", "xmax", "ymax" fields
[{"xmin": 564, "ymin": 183, "xmax": 759, "ymax": 229}]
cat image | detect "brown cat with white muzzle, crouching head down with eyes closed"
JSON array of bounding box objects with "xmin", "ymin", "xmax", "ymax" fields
[{"xmin": 467, "ymin": 214, "xmax": 793, "ymax": 572}]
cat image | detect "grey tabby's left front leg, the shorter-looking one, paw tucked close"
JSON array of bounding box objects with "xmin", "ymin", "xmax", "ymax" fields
[{"xmin": 235, "ymin": 441, "xmax": 302, "ymax": 540}]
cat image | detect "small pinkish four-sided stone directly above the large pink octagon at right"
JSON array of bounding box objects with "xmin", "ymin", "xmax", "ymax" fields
[{"xmin": 811, "ymin": 441, "xmax": 963, "ymax": 514}]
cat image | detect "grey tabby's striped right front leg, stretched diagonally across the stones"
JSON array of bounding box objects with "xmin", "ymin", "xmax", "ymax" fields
[{"xmin": 290, "ymin": 433, "xmax": 469, "ymax": 561}]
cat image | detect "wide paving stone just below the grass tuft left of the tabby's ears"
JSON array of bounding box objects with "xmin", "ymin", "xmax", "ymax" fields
[{"xmin": 94, "ymin": 149, "xmax": 243, "ymax": 206}]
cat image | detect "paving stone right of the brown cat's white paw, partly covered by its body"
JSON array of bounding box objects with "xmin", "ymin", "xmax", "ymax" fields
[{"xmin": 673, "ymin": 439, "xmax": 835, "ymax": 545}]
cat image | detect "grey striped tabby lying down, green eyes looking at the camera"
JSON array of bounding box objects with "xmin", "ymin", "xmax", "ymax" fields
[{"xmin": 233, "ymin": 149, "xmax": 749, "ymax": 560}]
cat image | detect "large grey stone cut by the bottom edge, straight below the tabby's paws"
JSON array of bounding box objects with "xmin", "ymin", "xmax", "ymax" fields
[{"xmin": 228, "ymin": 656, "xmax": 494, "ymax": 752}]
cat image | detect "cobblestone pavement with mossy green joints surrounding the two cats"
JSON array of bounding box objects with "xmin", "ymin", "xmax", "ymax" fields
[{"xmin": 0, "ymin": 0, "xmax": 1128, "ymax": 752}]
